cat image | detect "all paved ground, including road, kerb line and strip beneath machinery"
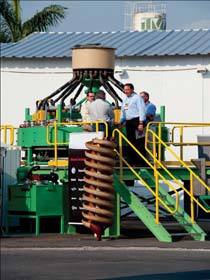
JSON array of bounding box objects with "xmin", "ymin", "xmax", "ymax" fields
[{"xmin": 1, "ymin": 222, "xmax": 210, "ymax": 280}]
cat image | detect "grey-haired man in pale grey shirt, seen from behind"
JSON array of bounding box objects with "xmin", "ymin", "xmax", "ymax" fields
[{"xmin": 89, "ymin": 90, "xmax": 114, "ymax": 137}]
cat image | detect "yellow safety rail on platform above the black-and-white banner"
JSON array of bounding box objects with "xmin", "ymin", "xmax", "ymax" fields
[{"xmin": 46, "ymin": 121, "xmax": 108, "ymax": 166}]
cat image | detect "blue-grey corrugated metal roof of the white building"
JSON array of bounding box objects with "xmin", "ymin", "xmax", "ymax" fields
[{"xmin": 1, "ymin": 29, "xmax": 210, "ymax": 58}]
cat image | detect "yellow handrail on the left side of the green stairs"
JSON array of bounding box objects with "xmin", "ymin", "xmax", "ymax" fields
[{"xmin": 112, "ymin": 129, "xmax": 179, "ymax": 224}]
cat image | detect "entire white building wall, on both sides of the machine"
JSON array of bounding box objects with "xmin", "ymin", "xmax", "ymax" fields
[{"xmin": 1, "ymin": 56, "xmax": 210, "ymax": 160}]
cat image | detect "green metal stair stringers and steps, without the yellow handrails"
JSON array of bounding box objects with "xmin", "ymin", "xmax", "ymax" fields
[{"xmin": 114, "ymin": 174, "xmax": 206, "ymax": 242}]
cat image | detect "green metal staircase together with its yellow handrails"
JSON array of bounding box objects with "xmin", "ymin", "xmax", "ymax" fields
[{"xmin": 110, "ymin": 128, "xmax": 210, "ymax": 242}]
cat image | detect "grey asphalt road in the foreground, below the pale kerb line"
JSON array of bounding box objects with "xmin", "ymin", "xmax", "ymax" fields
[{"xmin": 1, "ymin": 246, "xmax": 210, "ymax": 280}]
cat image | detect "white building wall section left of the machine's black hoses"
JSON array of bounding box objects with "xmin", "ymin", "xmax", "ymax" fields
[{"xmin": 1, "ymin": 59, "xmax": 72, "ymax": 125}]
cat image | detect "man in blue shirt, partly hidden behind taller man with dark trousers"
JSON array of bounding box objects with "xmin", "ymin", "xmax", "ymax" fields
[{"xmin": 138, "ymin": 91, "xmax": 156, "ymax": 162}]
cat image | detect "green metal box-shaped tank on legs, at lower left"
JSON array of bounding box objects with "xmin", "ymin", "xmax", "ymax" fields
[{"xmin": 6, "ymin": 183, "xmax": 67, "ymax": 235}]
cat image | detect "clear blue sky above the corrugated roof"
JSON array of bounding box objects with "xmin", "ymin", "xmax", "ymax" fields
[{"xmin": 21, "ymin": 0, "xmax": 210, "ymax": 32}]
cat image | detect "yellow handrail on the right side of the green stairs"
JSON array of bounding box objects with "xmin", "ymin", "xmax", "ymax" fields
[{"xmin": 145, "ymin": 127, "xmax": 210, "ymax": 222}]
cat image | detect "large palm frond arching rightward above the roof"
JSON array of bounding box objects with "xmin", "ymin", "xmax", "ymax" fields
[{"xmin": 23, "ymin": 5, "xmax": 66, "ymax": 36}]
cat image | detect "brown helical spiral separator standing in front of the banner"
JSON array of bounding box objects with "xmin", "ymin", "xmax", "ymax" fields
[{"xmin": 82, "ymin": 139, "xmax": 115, "ymax": 240}]
